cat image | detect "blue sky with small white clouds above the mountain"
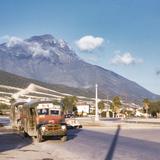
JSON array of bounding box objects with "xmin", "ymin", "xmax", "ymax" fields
[{"xmin": 0, "ymin": 0, "xmax": 160, "ymax": 95}]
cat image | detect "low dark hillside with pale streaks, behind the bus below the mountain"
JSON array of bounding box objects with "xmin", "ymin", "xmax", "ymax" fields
[{"xmin": 0, "ymin": 70, "xmax": 100, "ymax": 98}]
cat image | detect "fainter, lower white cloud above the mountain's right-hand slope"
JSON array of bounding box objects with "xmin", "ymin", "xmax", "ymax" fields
[{"xmin": 111, "ymin": 52, "xmax": 143, "ymax": 65}]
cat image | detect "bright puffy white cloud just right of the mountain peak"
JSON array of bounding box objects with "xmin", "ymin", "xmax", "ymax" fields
[{"xmin": 76, "ymin": 35, "xmax": 104, "ymax": 51}]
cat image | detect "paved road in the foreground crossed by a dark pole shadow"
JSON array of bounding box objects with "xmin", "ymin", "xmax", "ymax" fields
[{"xmin": 0, "ymin": 117, "xmax": 160, "ymax": 160}]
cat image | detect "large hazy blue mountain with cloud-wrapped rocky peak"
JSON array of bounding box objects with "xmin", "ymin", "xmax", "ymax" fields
[{"xmin": 0, "ymin": 35, "xmax": 160, "ymax": 101}]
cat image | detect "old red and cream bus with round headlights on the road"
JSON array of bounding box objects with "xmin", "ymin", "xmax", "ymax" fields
[{"xmin": 11, "ymin": 100, "xmax": 67, "ymax": 142}]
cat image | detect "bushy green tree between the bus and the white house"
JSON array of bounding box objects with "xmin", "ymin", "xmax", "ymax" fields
[{"xmin": 61, "ymin": 96, "xmax": 78, "ymax": 113}]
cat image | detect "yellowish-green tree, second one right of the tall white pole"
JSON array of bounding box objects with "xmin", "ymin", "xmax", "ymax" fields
[{"xmin": 110, "ymin": 96, "xmax": 122, "ymax": 117}]
